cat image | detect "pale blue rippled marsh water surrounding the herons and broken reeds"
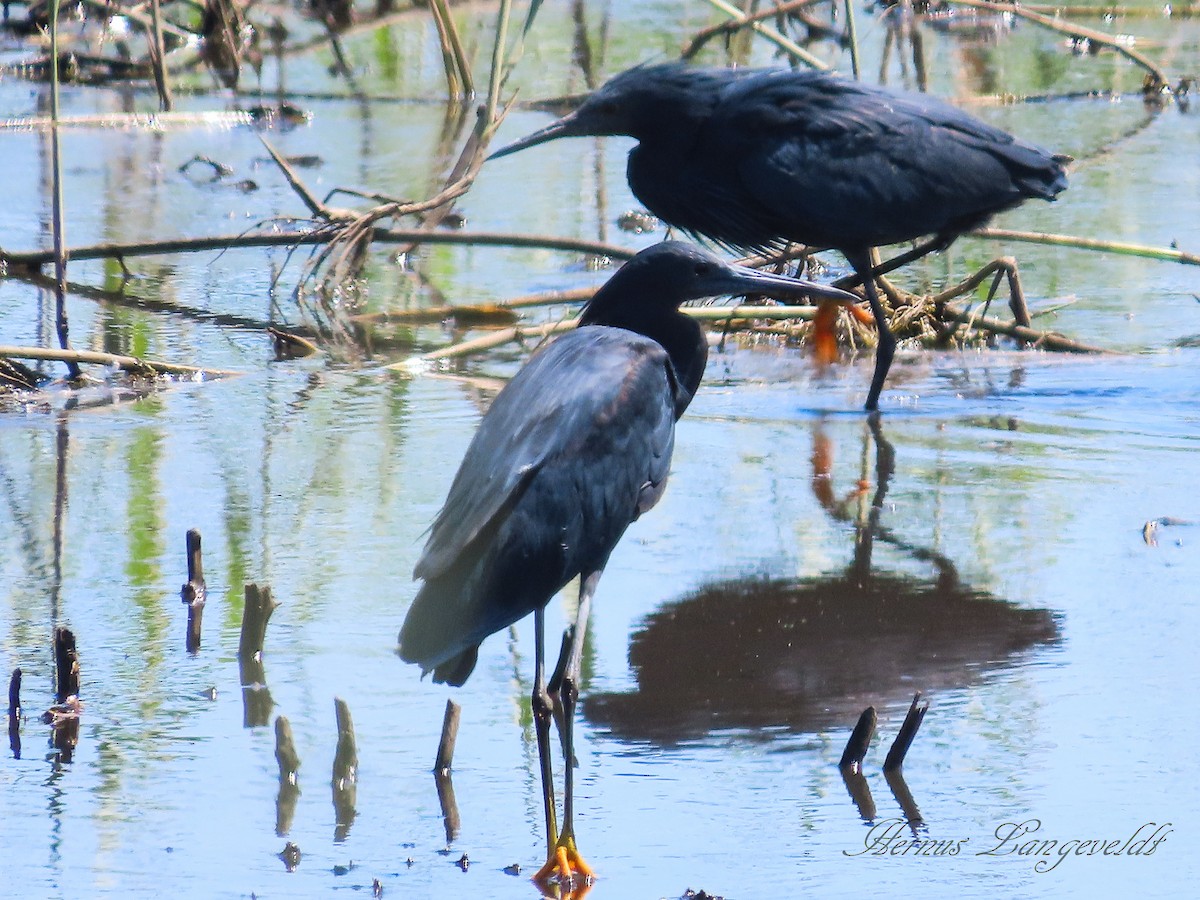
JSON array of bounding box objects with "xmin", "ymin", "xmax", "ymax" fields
[{"xmin": 0, "ymin": 4, "xmax": 1200, "ymax": 898}]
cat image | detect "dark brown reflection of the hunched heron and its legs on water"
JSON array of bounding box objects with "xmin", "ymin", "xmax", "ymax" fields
[{"xmin": 584, "ymin": 418, "xmax": 1060, "ymax": 744}]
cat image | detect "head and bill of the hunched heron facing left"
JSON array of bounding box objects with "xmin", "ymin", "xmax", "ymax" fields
[{"xmin": 487, "ymin": 62, "xmax": 726, "ymax": 160}]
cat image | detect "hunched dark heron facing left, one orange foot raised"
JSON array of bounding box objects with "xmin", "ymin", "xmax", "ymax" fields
[{"xmin": 491, "ymin": 64, "xmax": 1069, "ymax": 409}]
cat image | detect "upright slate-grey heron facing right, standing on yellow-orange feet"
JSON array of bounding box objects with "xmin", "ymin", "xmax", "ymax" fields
[{"xmin": 400, "ymin": 241, "xmax": 856, "ymax": 880}]
